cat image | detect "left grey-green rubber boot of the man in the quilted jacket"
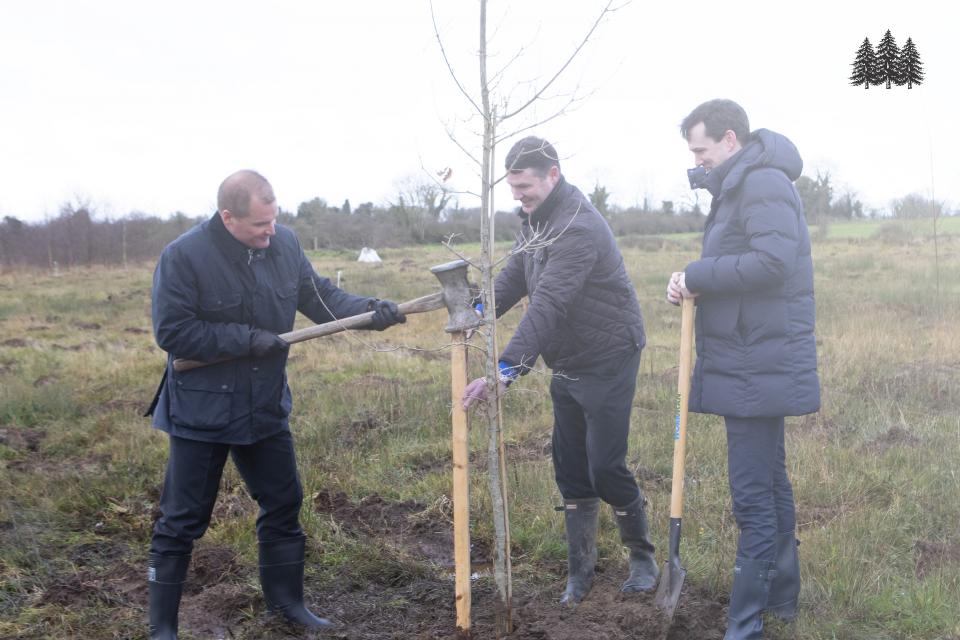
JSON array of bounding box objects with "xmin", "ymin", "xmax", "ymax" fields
[{"xmin": 560, "ymin": 498, "xmax": 600, "ymax": 607}]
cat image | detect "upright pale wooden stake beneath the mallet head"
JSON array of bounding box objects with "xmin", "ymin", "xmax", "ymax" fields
[{"xmin": 450, "ymin": 331, "xmax": 471, "ymax": 634}]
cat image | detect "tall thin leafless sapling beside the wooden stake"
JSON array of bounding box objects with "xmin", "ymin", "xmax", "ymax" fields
[{"xmin": 430, "ymin": 0, "xmax": 629, "ymax": 638}]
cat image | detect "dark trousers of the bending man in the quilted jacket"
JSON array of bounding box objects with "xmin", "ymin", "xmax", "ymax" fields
[{"xmin": 550, "ymin": 350, "xmax": 640, "ymax": 507}]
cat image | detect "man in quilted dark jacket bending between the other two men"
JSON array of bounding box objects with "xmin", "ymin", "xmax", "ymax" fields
[{"xmin": 464, "ymin": 136, "xmax": 658, "ymax": 606}]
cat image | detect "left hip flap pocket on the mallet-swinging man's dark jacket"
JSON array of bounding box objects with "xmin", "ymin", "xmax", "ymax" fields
[{"xmin": 169, "ymin": 365, "xmax": 235, "ymax": 429}]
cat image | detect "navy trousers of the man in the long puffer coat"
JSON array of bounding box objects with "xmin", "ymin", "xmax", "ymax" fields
[{"xmin": 724, "ymin": 417, "xmax": 796, "ymax": 561}]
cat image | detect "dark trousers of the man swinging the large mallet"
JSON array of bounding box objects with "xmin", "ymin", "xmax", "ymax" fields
[{"xmin": 150, "ymin": 431, "xmax": 303, "ymax": 555}]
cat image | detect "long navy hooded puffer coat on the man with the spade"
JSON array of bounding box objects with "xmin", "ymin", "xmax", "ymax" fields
[{"xmin": 685, "ymin": 129, "xmax": 820, "ymax": 418}]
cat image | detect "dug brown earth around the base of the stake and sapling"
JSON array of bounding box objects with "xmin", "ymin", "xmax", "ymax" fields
[{"xmin": 288, "ymin": 566, "xmax": 725, "ymax": 640}]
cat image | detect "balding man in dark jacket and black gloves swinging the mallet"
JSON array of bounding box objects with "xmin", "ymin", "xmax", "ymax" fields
[{"xmin": 148, "ymin": 171, "xmax": 406, "ymax": 640}]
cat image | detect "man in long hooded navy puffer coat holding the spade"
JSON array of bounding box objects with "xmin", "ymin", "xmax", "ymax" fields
[{"xmin": 667, "ymin": 100, "xmax": 820, "ymax": 640}]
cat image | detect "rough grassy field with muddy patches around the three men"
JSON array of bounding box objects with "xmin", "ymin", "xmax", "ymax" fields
[{"xmin": 0, "ymin": 219, "xmax": 960, "ymax": 640}]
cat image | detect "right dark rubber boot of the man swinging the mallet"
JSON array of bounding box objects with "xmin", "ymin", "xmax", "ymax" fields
[{"xmin": 260, "ymin": 536, "xmax": 337, "ymax": 629}]
